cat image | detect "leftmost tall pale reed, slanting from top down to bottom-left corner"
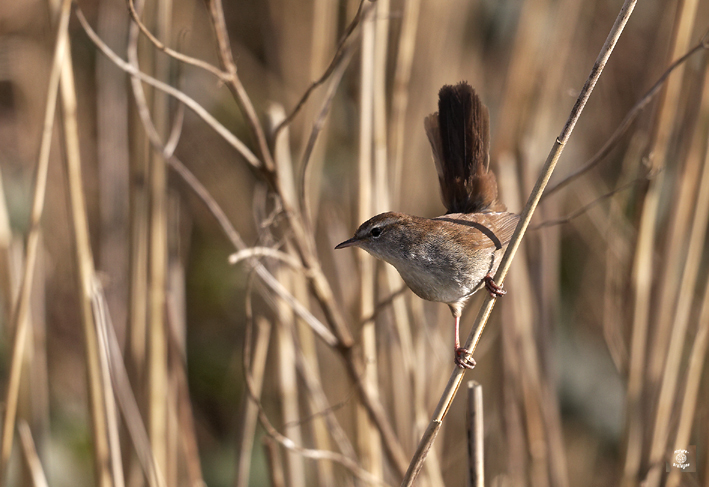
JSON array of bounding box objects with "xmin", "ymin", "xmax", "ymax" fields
[{"xmin": 0, "ymin": 0, "xmax": 71, "ymax": 485}]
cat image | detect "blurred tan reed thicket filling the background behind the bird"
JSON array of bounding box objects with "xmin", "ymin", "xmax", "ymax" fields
[{"xmin": 0, "ymin": 0, "xmax": 709, "ymax": 487}]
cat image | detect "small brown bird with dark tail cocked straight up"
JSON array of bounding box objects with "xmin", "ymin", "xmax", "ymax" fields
[{"xmin": 335, "ymin": 82, "xmax": 519, "ymax": 369}]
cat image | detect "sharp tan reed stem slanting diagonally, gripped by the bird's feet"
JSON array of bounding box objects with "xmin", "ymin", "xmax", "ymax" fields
[{"xmin": 401, "ymin": 0, "xmax": 637, "ymax": 486}]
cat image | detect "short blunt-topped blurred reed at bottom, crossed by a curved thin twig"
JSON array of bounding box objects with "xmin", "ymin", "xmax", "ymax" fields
[{"xmin": 234, "ymin": 318, "xmax": 271, "ymax": 487}]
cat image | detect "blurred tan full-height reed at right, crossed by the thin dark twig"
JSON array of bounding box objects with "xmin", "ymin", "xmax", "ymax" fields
[{"xmin": 623, "ymin": 0, "xmax": 697, "ymax": 486}]
